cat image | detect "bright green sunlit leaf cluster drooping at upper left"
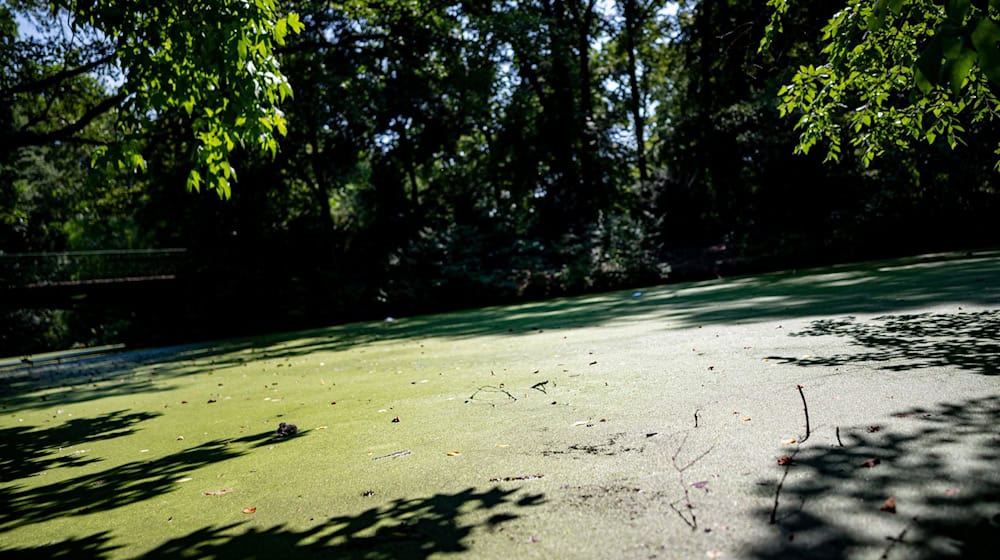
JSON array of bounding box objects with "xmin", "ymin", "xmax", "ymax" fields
[{"xmin": 44, "ymin": 0, "xmax": 303, "ymax": 197}]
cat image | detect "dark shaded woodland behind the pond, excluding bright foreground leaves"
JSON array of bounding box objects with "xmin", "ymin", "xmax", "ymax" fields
[{"xmin": 0, "ymin": 0, "xmax": 1000, "ymax": 355}]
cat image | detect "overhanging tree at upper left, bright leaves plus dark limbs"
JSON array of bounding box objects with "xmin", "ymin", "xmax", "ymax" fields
[{"xmin": 0, "ymin": 0, "xmax": 302, "ymax": 197}]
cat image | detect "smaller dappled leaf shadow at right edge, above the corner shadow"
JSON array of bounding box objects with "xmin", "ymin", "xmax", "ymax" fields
[{"xmin": 771, "ymin": 310, "xmax": 1000, "ymax": 375}]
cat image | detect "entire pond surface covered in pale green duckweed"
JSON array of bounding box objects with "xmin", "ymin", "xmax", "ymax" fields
[{"xmin": 0, "ymin": 253, "xmax": 1000, "ymax": 559}]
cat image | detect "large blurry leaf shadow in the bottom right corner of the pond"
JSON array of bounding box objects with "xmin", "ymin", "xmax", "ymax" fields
[{"xmin": 751, "ymin": 395, "xmax": 1000, "ymax": 560}]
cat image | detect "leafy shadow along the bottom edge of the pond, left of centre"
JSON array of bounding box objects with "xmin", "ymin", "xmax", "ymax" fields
[{"xmin": 0, "ymin": 487, "xmax": 544, "ymax": 560}]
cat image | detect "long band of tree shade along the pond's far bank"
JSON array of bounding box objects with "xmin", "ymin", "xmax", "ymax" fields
[{"xmin": 0, "ymin": 253, "xmax": 1000, "ymax": 411}]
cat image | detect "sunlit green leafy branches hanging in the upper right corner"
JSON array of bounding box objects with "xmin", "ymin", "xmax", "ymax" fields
[{"xmin": 761, "ymin": 0, "xmax": 1000, "ymax": 170}]
